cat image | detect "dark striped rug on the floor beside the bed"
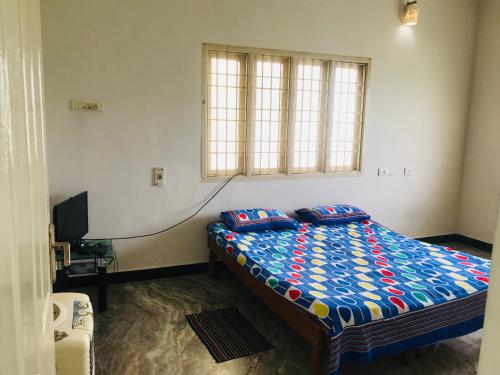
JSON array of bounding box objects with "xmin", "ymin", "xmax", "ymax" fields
[{"xmin": 186, "ymin": 308, "xmax": 273, "ymax": 363}]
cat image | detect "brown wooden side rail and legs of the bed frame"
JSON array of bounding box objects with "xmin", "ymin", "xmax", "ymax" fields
[{"xmin": 208, "ymin": 237, "xmax": 329, "ymax": 375}]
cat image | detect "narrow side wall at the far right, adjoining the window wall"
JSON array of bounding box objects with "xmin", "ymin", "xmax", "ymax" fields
[{"xmin": 459, "ymin": 0, "xmax": 500, "ymax": 243}]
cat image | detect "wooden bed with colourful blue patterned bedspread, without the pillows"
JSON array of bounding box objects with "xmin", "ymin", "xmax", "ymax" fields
[{"xmin": 208, "ymin": 220, "xmax": 490, "ymax": 375}]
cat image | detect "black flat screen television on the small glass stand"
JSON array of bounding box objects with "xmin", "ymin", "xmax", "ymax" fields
[{"xmin": 52, "ymin": 191, "xmax": 89, "ymax": 243}]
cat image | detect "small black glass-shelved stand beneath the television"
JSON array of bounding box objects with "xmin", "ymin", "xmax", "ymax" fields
[{"xmin": 54, "ymin": 240, "xmax": 115, "ymax": 311}]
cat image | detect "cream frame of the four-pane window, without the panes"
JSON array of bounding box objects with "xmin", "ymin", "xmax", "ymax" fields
[{"xmin": 201, "ymin": 43, "xmax": 372, "ymax": 181}]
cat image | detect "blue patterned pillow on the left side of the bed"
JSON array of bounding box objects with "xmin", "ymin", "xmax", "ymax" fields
[{"xmin": 220, "ymin": 208, "xmax": 299, "ymax": 232}]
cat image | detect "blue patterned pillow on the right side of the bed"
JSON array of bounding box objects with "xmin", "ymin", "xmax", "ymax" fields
[{"xmin": 295, "ymin": 204, "xmax": 370, "ymax": 225}]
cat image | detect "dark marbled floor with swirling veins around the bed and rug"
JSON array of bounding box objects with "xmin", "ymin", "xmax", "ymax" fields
[{"xmin": 78, "ymin": 243, "xmax": 490, "ymax": 375}]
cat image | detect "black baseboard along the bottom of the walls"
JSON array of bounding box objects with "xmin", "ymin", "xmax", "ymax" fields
[{"xmin": 62, "ymin": 233, "xmax": 493, "ymax": 288}]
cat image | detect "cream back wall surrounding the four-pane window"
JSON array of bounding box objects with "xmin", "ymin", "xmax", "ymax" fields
[{"xmin": 42, "ymin": 0, "xmax": 477, "ymax": 270}]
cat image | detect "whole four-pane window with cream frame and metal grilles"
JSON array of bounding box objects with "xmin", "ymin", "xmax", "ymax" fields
[{"xmin": 203, "ymin": 45, "xmax": 369, "ymax": 177}]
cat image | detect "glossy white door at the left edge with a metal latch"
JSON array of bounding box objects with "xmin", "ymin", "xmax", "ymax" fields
[{"xmin": 0, "ymin": 0, "xmax": 55, "ymax": 375}]
